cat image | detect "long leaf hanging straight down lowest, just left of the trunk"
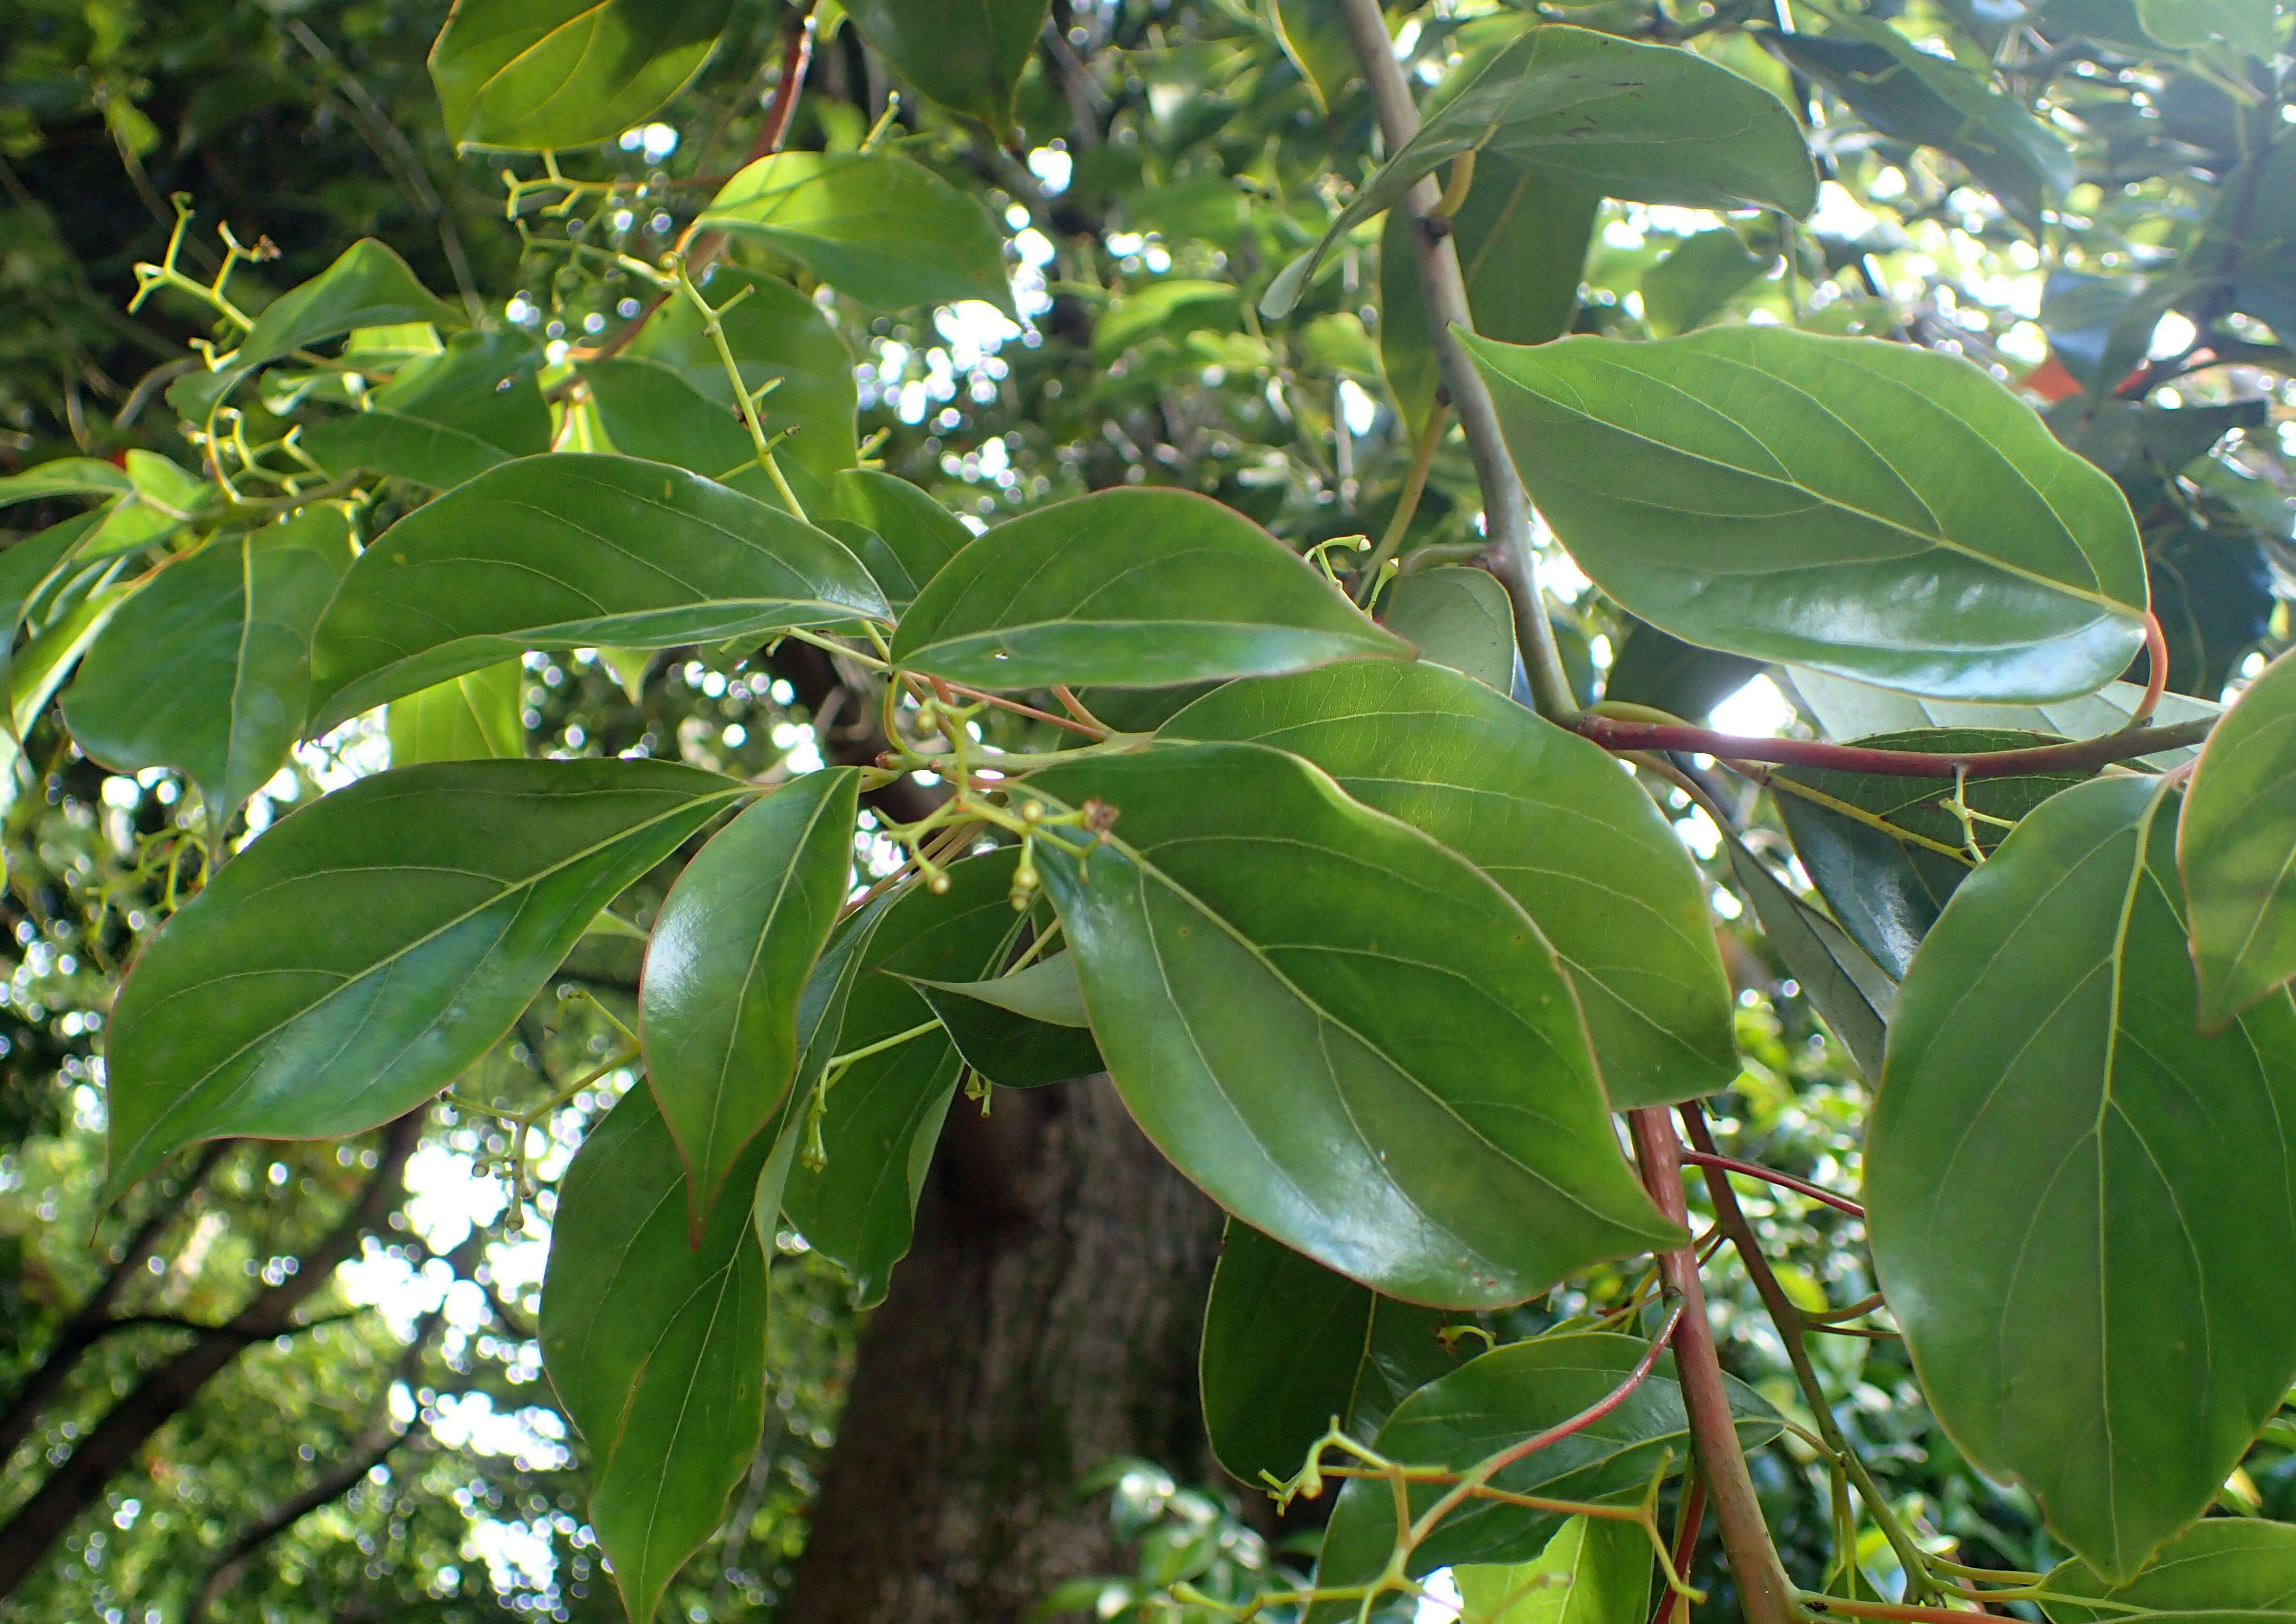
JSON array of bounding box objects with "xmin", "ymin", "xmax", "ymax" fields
[{"xmin": 540, "ymin": 1084, "xmax": 767, "ymax": 1624}]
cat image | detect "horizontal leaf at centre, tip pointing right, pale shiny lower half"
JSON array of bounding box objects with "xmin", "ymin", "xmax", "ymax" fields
[{"xmin": 893, "ymin": 490, "xmax": 1410, "ymax": 689}]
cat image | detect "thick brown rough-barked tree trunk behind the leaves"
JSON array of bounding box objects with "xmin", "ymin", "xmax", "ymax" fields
[{"xmin": 781, "ymin": 1077, "xmax": 1219, "ymax": 1624}]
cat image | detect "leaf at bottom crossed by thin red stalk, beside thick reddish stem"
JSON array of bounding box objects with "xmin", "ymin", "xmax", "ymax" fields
[{"xmin": 1307, "ymin": 1332, "xmax": 1780, "ymax": 1624}]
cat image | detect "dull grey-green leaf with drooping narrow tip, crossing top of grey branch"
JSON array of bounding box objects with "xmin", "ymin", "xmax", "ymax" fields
[{"xmin": 1261, "ymin": 23, "xmax": 1818, "ymax": 317}]
